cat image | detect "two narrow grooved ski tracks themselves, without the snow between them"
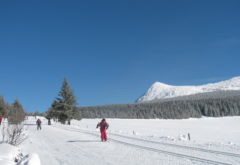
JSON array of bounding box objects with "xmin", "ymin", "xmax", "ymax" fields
[{"xmin": 53, "ymin": 125, "xmax": 234, "ymax": 165}]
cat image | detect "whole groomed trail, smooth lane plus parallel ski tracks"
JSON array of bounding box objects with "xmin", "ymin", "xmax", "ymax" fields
[{"xmin": 22, "ymin": 118, "xmax": 240, "ymax": 165}]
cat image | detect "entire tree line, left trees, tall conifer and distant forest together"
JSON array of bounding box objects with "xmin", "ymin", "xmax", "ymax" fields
[{"xmin": 3, "ymin": 78, "xmax": 240, "ymax": 124}]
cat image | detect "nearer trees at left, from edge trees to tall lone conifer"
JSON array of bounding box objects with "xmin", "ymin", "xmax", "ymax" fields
[{"xmin": 0, "ymin": 78, "xmax": 81, "ymax": 124}]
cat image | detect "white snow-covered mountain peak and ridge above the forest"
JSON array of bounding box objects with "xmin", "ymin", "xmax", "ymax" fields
[{"xmin": 137, "ymin": 77, "xmax": 240, "ymax": 102}]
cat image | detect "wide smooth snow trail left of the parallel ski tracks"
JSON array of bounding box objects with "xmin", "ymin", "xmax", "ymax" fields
[{"xmin": 20, "ymin": 122, "xmax": 193, "ymax": 165}]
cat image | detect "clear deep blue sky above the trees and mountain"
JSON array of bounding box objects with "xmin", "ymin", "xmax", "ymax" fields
[{"xmin": 0, "ymin": 0, "xmax": 240, "ymax": 111}]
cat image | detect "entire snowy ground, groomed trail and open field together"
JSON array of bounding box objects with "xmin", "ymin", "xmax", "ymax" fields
[{"xmin": 16, "ymin": 117, "xmax": 240, "ymax": 165}]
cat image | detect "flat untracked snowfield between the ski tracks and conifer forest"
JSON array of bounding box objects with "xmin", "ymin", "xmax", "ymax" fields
[{"xmin": 72, "ymin": 117, "xmax": 240, "ymax": 145}]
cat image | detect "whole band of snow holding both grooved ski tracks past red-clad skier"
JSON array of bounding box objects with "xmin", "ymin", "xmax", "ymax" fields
[{"xmin": 54, "ymin": 125, "xmax": 240, "ymax": 165}]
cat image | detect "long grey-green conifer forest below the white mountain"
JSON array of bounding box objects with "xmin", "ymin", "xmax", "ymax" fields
[{"xmin": 78, "ymin": 91, "xmax": 240, "ymax": 119}]
